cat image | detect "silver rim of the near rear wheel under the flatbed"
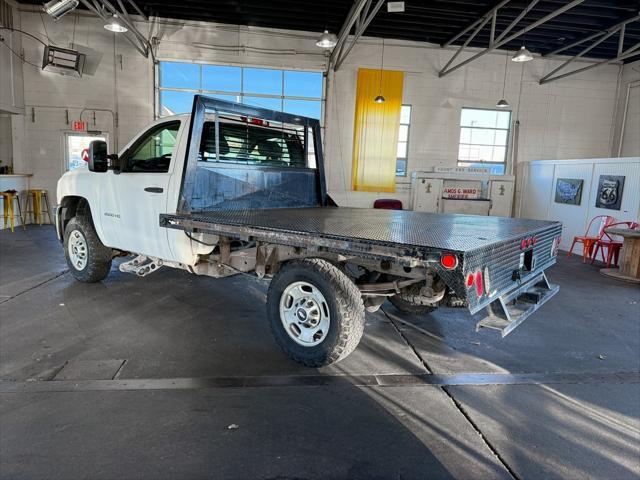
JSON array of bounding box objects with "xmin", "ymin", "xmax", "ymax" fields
[{"xmin": 280, "ymin": 282, "xmax": 331, "ymax": 347}]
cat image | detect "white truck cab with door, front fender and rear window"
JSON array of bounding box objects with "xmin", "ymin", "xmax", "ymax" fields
[{"xmin": 56, "ymin": 111, "xmax": 318, "ymax": 266}]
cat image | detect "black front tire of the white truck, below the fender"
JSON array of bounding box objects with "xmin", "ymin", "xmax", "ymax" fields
[{"xmin": 64, "ymin": 216, "xmax": 113, "ymax": 283}]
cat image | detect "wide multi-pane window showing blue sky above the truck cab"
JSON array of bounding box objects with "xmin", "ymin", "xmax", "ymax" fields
[{"xmin": 159, "ymin": 62, "xmax": 323, "ymax": 119}]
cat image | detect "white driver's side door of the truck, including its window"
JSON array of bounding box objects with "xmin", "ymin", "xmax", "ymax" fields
[{"xmin": 100, "ymin": 121, "xmax": 180, "ymax": 259}]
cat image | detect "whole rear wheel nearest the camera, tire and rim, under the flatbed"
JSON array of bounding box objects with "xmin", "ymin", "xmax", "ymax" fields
[{"xmin": 267, "ymin": 258, "xmax": 364, "ymax": 367}]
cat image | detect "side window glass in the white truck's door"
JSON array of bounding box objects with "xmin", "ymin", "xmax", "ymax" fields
[{"xmin": 124, "ymin": 122, "xmax": 180, "ymax": 173}]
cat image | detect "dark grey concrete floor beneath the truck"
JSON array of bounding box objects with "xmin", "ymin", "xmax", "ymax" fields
[{"xmin": 0, "ymin": 226, "xmax": 640, "ymax": 479}]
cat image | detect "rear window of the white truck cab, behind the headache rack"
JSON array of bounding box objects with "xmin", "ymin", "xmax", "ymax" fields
[{"xmin": 198, "ymin": 122, "xmax": 306, "ymax": 168}]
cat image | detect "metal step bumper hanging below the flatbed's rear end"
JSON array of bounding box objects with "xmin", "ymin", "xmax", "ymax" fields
[{"xmin": 476, "ymin": 272, "xmax": 560, "ymax": 337}]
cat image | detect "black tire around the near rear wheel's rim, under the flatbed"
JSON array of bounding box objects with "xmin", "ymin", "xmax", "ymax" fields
[{"xmin": 267, "ymin": 258, "xmax": 365, "ymax": 367}]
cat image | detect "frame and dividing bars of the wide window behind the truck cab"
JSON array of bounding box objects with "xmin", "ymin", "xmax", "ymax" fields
[{"xmin": 154, "ymin": 59, "xmax": 327, "ymax": 125}]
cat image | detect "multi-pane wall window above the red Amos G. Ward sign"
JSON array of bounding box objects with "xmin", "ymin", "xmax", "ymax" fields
[{"xmin": 458, "ymin": 108, "xmax": 511, "ymax": 175}]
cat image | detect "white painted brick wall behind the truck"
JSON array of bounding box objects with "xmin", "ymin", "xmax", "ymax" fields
[{"xmin": 14, "ymin": 11, "xmax": 619, "ymax": 210}]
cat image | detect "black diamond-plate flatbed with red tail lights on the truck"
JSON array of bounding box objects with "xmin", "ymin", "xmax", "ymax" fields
[{"xmin": 160, "ymin": 207, "xmax": 561, "ymax": 320}]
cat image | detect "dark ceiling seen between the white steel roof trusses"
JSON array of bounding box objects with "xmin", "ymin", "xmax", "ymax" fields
[{"xmin": 22, "ymin": 0, "xmax": 640, "ymax": 60}]
